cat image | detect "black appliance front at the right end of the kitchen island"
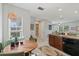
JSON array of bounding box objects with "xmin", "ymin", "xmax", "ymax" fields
[{"xmin": 63, "ymin": 38, "xmax": 79, "ymax": 56}]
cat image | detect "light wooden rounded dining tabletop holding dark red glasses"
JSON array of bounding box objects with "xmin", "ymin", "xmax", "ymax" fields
[{"xmin": 3, "ymin": 40, "xmax": 37, "ymax": 53}]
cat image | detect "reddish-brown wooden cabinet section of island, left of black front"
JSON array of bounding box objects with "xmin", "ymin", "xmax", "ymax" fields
[{"xmin": 49, "ymin": 35, "xmax": 63, "ymax": 51}]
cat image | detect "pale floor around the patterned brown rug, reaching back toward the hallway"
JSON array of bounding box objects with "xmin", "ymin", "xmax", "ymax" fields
[{"xmin": 32, "ymin": 40, "xmax": 67, "ymax": 56}]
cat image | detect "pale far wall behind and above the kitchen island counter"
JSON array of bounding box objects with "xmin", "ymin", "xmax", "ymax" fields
[{"xmin": 45, "ymin": 20, "xmax": 79, "ymax": 36}]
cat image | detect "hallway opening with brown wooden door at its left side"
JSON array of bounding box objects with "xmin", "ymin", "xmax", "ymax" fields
[{"xmin": 35, "ymin": 21, "xmax": 45, "ymax": 41}]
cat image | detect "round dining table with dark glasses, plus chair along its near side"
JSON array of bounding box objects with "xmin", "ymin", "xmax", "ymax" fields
[{"xmin": 0, "ymin": 39, "xmax": 37, "ymax": 56}]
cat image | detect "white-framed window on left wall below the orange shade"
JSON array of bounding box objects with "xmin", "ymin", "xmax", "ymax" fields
[{"xmin": 8, "ymin": 18, "xmax": 23, "ymax": 39}]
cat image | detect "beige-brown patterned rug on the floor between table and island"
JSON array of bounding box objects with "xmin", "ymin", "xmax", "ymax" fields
[{"xmin": 31, "ymin": 46, "xmax": 70, "ymax": 56}]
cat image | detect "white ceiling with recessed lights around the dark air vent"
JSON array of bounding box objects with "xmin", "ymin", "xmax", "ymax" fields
[{"xmin": 12, "ymin": 3, "xmax": 79, "ymax": 22}]
